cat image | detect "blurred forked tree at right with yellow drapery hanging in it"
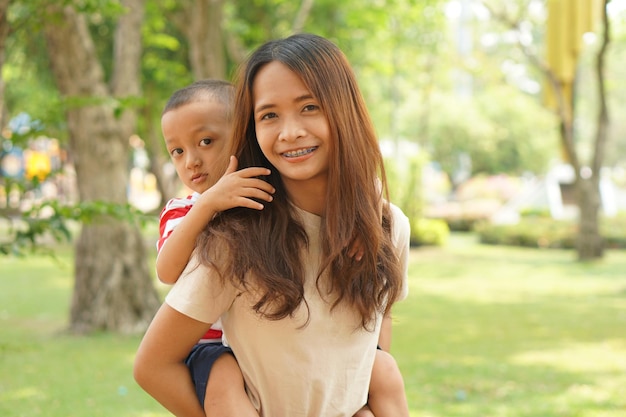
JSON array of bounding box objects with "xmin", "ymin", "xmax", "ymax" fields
[{"xmin": 483, "ymin": 0, "xmax": 611, "ymax": 260}]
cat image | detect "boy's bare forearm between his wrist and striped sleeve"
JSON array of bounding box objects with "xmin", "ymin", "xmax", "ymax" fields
[{"xmin": 156, "ymin": 199, "xmax": 217, "ymax": 284}]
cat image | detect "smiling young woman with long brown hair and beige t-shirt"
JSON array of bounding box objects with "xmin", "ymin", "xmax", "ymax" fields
[{"xmin": 135, "ymin": 34, "xmax": 409, "ymax": 417}]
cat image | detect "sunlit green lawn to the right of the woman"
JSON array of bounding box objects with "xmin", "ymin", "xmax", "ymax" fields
[{"xmin": 392, "ymin": 235, "xmax": 626, "ymax": 417}]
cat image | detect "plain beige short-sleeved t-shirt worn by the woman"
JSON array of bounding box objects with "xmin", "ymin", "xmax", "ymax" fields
[{"xmin": 166, "ymin": 205, "xmax": 409, "ymax": 417}]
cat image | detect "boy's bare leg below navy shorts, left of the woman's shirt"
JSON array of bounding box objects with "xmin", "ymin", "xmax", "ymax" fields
[{"xmin": 204, "ymin": 353, "xmax": 259, "ymax": 417}]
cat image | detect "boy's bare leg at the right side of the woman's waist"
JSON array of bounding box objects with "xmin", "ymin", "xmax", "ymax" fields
[{"xmin": 367, "ymin": 349, "xmax": 409, "ymax": 417}]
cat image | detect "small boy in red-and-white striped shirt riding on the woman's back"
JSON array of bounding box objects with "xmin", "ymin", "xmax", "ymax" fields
[{"xmin": 156, "ymin": 80, "xmax": 407, "ymax": 417}]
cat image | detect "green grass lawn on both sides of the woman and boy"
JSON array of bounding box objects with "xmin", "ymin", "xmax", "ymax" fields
[{"xmin": 0, "ymin": 235, "xmax": 626, "ymax": 417}]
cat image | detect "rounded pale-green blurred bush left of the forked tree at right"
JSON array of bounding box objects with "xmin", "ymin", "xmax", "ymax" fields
[{"xmin": 429, "ymin": 87, "xmax": 558, "ymax": 178}]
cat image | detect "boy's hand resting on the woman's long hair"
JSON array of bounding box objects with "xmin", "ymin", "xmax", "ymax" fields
[{"xmin": 196, "ymin": 156, "xmax": 276, "ymax": 212}]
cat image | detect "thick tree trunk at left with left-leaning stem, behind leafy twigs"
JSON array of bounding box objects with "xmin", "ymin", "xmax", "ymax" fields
[{"xmin": 44, "ymin": 6, "xmax": 160, "ymax": 333}]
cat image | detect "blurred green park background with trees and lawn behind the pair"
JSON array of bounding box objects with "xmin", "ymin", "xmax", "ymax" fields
[{"xmin": 0, "ymin": 0, "xmax": 626, "ymax": 417}]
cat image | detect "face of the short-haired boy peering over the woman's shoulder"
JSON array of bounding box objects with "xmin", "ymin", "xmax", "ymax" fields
[{"xmin": 161, "ymin": 99, "xmax": 232, "ymax": 193}]
